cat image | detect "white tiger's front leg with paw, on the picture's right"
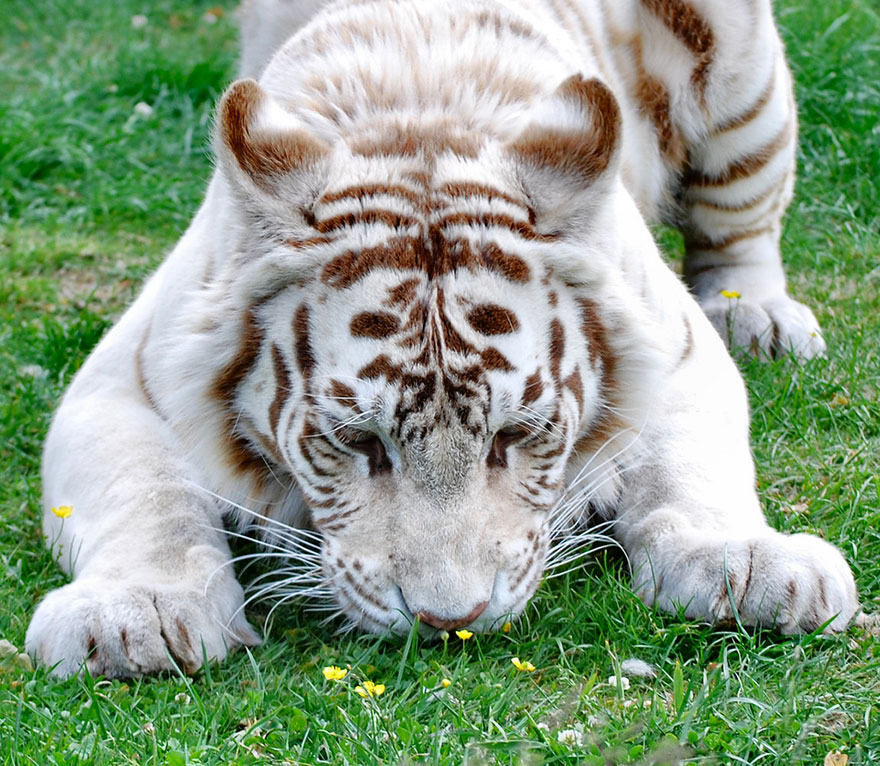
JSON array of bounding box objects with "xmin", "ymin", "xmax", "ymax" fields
[{"xmin": 616, "ymin": 307, "xmax": 859, "ymax": 633}]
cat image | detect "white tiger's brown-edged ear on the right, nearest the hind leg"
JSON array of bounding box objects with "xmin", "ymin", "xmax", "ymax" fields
[{"xmin": 508, "ymin": 74, "xmax": 622, "ymax": 228}]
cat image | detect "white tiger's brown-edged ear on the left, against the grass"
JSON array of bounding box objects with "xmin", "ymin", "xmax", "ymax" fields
[{"xmin": 215, "ymin": 79, "xmax": 330, "ymax": 193}]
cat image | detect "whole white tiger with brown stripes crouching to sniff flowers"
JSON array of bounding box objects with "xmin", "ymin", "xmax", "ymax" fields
[{"xmin": 27, "ymin": 0, "xmax": 858, "ymax": 676}]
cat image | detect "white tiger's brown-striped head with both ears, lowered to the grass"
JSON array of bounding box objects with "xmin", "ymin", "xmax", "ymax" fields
[{"xmin": 208, "ymin": 77, "xmax": 660, "ymax": 635}]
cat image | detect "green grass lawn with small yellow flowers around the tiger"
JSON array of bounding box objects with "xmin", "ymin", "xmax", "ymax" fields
[{"xmin": 0, "ymin": 0, "xmax": 880, "ymax": 766}]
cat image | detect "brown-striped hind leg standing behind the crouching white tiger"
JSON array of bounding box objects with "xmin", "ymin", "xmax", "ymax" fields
[{"xmin": 680, "ymin": 2, "xmax": 825, "ymax": 358}]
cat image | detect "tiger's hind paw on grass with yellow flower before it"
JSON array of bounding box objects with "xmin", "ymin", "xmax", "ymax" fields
[{"xmin": 700, "ymin": 290, "xmax": 825, "ymax": 359}]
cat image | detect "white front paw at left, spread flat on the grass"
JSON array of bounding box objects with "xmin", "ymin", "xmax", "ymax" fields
[{"xmin": 26, "ymin": 579, "xmax": 260, "ymax": 678}]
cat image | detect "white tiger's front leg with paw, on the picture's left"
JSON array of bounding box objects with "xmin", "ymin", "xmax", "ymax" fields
[{"xmin": 26, "ymin": 280, "xmax": 258, "ymax": 677}]
